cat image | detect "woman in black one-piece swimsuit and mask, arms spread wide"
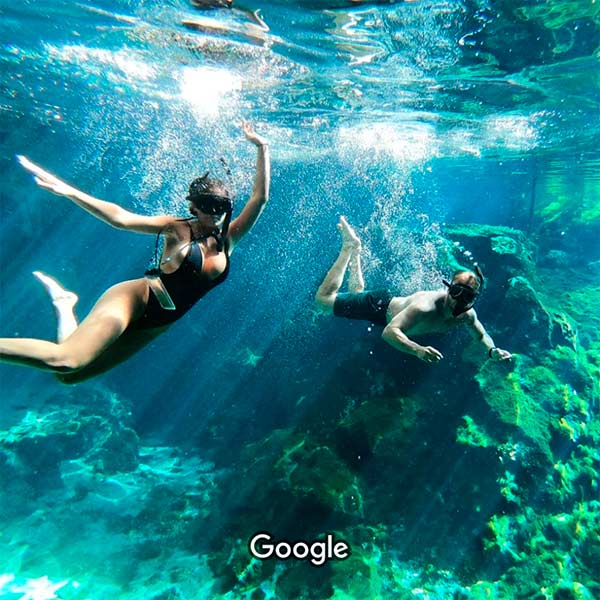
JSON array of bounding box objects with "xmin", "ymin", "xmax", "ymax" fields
[{"xmin": 0, "ymin": 122, "xmax": 270, "ymax": 383}]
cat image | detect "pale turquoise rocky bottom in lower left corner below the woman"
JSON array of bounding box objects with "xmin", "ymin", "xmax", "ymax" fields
[{"xmin": 0, "ymin": 388, "xmax": 220, "ymax": 599}]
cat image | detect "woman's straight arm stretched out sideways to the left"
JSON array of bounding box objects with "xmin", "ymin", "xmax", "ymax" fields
[{"xmin": 17, "ymin": 156, "xmax": 174, "ymax": 233}]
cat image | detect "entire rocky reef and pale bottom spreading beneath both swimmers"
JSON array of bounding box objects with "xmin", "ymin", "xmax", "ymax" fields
[{"xmin": 0, "ymin": 225, "xmax": 600, "ymax": 600}]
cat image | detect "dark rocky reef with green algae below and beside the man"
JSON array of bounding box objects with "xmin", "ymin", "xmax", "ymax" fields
[{"xmin": 195, "ymin": 225, "xmax": 600, "ymax": 599}]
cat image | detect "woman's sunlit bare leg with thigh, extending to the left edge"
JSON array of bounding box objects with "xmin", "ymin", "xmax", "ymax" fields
[{"xmin": 0, "ymin": 279, "xmax": 149, "ymax": 373}]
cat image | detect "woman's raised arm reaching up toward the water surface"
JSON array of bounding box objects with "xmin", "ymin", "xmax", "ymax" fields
[{"xmin": 229, "ymin": 121, "xmax": 271, "ymax": 248}]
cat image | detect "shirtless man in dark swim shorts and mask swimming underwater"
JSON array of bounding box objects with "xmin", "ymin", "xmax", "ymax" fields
[{"xmin": 315, "ymin": 217, "xmax": 511, "ymax": 363}]
